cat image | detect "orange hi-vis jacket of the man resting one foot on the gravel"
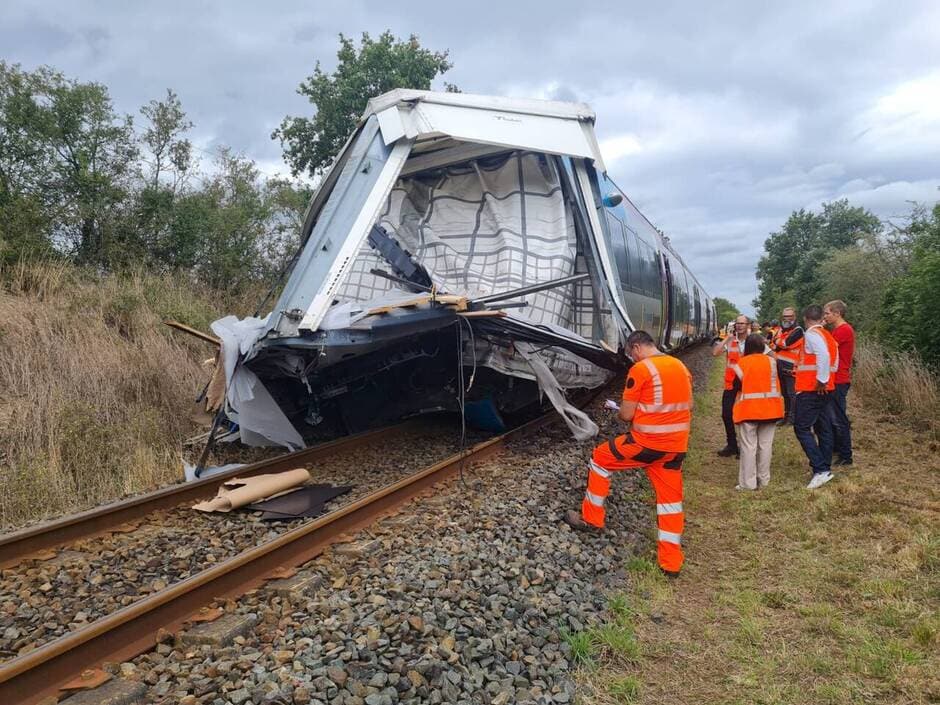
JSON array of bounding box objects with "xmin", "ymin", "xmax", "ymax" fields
[{"xmin": 628, "ymin": 355, "xmax": 692, "ymax": 453}]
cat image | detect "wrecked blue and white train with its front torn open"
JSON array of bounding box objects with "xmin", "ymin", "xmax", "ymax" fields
[{"xmin": 213, "ymin": 90, "xmax": 717, "ymax": 447}]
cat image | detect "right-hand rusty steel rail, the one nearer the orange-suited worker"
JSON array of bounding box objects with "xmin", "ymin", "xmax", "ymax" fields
[{"xmin": 0, "ymin": 404, "xmax": 558, "ymax": 705}]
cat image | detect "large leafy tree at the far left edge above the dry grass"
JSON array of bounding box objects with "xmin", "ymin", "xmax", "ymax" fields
[{"xmin": 0, "ymin": 64, "xmax": 137, "ymax": 264}]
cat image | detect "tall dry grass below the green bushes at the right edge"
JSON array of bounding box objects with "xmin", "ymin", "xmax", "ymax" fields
[{"xmin": 852, "ymin": 340, "xmax": 940, "ymax": 439}]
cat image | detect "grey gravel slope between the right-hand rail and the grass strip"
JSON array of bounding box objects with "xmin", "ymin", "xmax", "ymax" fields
[{"xmin": 106, "ymin": 349, "xmax": 707, "ymax": 705}]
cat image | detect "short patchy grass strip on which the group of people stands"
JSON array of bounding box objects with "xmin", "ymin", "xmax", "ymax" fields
[{"xmin": 569, "ymin": 352, "xmax": 940, "ymax": 705}]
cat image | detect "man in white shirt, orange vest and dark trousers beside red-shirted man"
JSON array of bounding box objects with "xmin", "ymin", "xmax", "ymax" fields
[{"xmin": 793, "ymin": 304, "xmax": 835, "ymax": 489}]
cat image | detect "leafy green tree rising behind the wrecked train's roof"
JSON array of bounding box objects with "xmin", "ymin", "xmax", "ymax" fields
[{"xmin": 271, "ymin": 30, "xmax": 456, "ymax": 177}]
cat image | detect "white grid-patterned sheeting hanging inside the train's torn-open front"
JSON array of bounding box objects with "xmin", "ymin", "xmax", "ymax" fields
[{"xmin": 337, "ymin": 153, "xmax": 593, "ymax": 339}]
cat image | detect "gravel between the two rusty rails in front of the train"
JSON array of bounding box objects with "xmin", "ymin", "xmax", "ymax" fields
[{"xmin": 0, "ymin": 423, "xmax": 484, "ymax": 661}]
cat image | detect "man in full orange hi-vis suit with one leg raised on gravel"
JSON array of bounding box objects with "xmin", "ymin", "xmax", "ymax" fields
[{"xmin": 565, "ymin": 331, "xmax": 692, "ymax": 577}]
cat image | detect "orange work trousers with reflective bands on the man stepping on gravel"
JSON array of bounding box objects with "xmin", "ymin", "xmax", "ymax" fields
[{"xmin": 581, "ymin": 433, "xmax": 685, "ymax": 573}]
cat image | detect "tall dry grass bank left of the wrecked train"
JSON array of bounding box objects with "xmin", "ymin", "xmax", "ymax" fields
[{"xmin": 0, "ymin": 264, "xmax": 239, "ymax": 527}]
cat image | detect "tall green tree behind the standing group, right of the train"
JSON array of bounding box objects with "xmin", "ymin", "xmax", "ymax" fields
[{"xmin": 754, "ymin": 199, "xmax": 882, "ymax": 318}]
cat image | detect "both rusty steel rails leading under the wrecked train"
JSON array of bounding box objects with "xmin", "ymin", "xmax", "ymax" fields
[{"xmin": 0, "ymin": 402, "xmax": 572, "ymax": 705}]
